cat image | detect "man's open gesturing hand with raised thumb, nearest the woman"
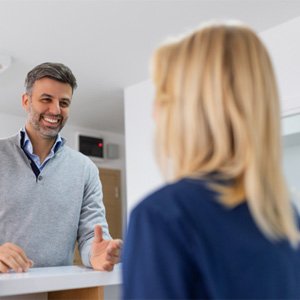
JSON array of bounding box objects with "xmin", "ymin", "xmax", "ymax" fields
[{"xmin": 90, "ymin": 225, "xmax": 123, "ymax": 271}]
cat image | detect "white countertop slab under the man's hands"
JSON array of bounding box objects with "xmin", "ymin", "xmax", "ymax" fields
[{"xmin": 0, "ymin": 264, "xmax": 121, "ymax": 296}]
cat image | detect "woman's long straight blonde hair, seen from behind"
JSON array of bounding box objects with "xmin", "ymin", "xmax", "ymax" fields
[{"xmin": 153, "ymin": 23, "xmax": 299, "ymax": 245}]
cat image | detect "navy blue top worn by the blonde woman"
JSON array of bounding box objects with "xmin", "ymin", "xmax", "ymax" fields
[{"xmin": 122, "ymin": 179, "xmax": 300, "ymax": 299}]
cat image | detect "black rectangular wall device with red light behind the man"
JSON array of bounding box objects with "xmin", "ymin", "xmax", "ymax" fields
[{"xmin": 79, "ymin": 135, "xmax": 104, "ymax": 158}]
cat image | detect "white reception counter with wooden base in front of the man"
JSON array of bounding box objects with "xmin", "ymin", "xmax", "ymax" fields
[{"xmin": 0, "ymin": 264, "xmax": 121, "ymax": 300}]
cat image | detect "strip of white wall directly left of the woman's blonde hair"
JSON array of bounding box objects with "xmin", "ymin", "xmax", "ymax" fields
[{"xmin": 124, "ymin": 81, "xmax": 163, "ymax": 213}]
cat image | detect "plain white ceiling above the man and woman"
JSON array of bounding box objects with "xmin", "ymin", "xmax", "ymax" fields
[{"xmin": 0, "ymin": 0, "xmax": 300, "ymax": 133}]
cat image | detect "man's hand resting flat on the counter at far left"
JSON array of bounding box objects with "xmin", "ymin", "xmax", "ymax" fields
[{"xmin": 0, "ymin": 243, "xmax": 33, "ymax": 273}]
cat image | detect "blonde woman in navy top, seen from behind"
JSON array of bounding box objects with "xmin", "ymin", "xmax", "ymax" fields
[{"xmin": 123, "ymin": 23, "xmax": 300, "ymax": 299}]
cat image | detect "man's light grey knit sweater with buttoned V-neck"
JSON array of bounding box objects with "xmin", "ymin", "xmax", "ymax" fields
[{"xmin": 0, "ymin": 135, "xmax": 111, "ymax": 267}]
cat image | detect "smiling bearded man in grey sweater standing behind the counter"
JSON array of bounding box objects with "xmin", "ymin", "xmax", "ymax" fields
[{"xmin": 0, "ymin": 63, "xmax": 122, "ymax": 273}]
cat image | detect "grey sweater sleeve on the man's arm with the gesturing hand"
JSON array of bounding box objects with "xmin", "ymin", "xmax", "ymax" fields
[{"xmin": 77, "ymin": 164, "xmax": 111, "ymax": 267}]
